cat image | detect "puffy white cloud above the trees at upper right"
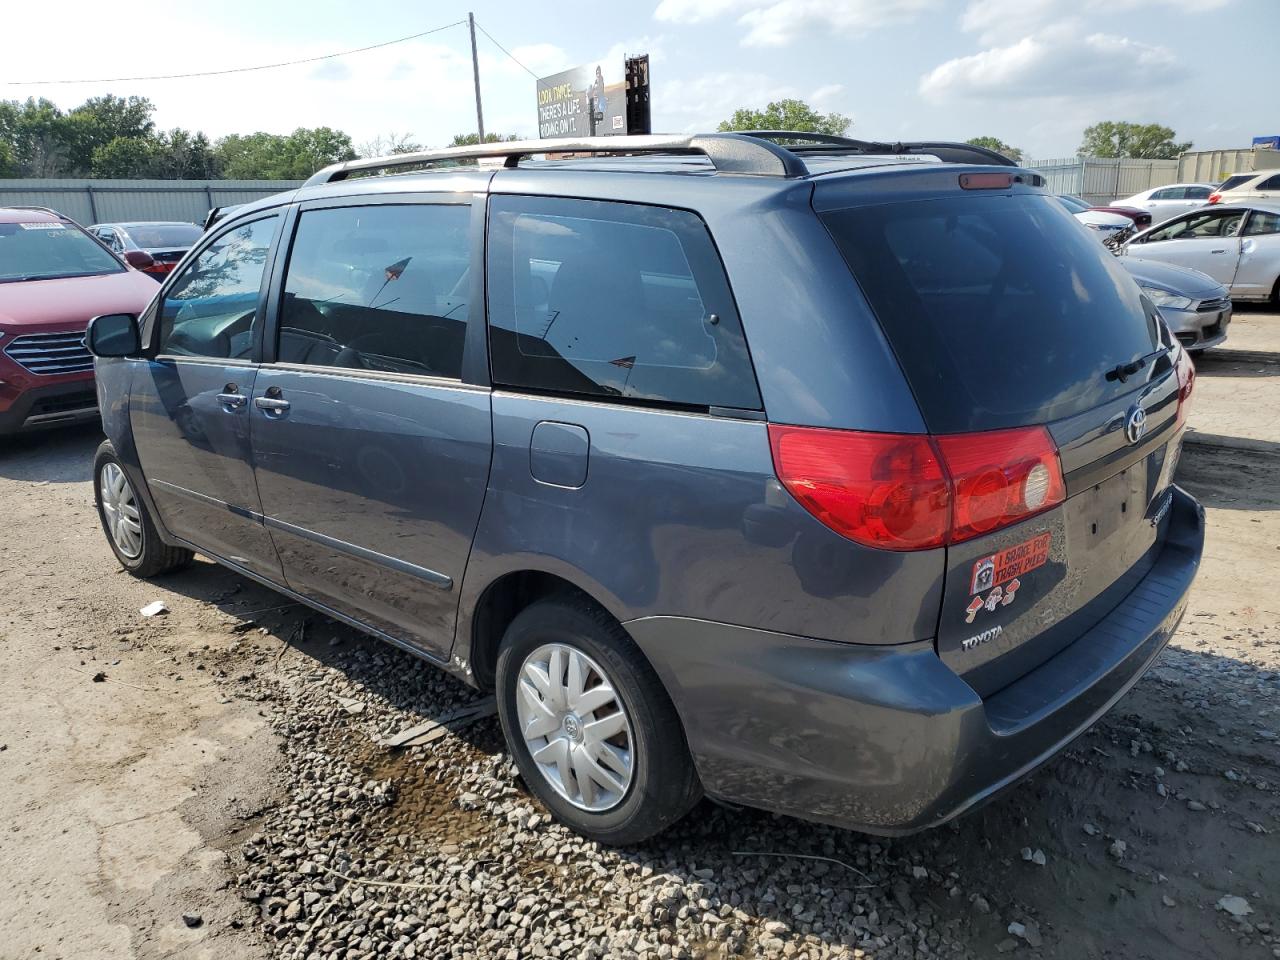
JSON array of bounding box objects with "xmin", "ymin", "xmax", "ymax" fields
[{"xmin": 919, "ymin": 27, "xmax": 1180, "ymax": 101}]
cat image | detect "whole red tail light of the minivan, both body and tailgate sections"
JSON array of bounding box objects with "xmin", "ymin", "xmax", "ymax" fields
[{"xmin": 769, "ymin": 424, "xmax": 1066, "ymax": 550}]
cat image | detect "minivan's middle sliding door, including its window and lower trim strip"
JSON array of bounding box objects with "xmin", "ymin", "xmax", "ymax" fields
[{"xmin": 251, "ymin": 195, "xmax": 492, "ymax": 658}]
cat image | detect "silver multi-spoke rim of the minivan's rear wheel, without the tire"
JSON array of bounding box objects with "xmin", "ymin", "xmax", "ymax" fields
[{"xmin": 516, "ymin": 644, "xmax": 635, "ymax": 813}]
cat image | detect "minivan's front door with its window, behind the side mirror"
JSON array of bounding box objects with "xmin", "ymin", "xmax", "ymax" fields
[{"xmin": 129, "ymin": 214, "xmax": 280, "ymax": 581}]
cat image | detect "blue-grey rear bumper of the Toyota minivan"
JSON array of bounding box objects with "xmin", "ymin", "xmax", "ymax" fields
[{"xmin": 626, "ymin": 488, "xmax": 1204, "ymax": 835}]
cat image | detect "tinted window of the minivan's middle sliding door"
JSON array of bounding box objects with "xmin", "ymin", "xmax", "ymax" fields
[{"xmin": 276, "ymin": 204, "xmax": 471, "ymax": 379}]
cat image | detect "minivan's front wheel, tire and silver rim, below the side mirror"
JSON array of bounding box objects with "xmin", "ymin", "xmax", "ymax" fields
[{"xmin": 93, "ymin": 440, "xmax": 195, "ymax": 579}]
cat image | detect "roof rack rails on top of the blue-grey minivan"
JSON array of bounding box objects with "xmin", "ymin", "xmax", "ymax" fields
[{"xmin": 303, "ymin": 131, "xmax": 1016, "ymax": 187}]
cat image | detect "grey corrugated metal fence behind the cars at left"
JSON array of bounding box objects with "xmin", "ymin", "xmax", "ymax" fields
[{"xmin": 0, "ymin": 179, "xmax": 302, "ymax": 225}]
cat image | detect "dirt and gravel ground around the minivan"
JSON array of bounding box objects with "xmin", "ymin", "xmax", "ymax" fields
[{"xmin": 0, "ymin": 311, "xmax": 1280, "ymax": 960}]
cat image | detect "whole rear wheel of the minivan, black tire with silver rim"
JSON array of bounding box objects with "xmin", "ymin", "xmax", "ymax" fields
[{"xmin": 497, "ymin": 596, "xmax": 701, "ymax": 846}]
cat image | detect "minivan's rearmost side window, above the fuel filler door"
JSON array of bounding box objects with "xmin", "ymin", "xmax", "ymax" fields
[{"xmin": 489, "ymin": 196, "xmax": 760, "ymax": 410}]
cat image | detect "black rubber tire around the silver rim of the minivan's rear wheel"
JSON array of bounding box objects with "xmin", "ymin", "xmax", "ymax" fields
[{"xmin": 497, "ymin": 595, "xmax": 701, "ymax": 846}]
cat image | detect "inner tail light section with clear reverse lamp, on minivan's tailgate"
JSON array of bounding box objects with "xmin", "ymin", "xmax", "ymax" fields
[{"xmin": 933, "ymin": 426, "xmax": 1066, "ymax": 543}]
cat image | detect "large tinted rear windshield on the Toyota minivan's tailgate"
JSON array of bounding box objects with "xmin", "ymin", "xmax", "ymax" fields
[{"xmin": 823, "ymin": 195, "xmax": 1157, "ymax": 433}]
